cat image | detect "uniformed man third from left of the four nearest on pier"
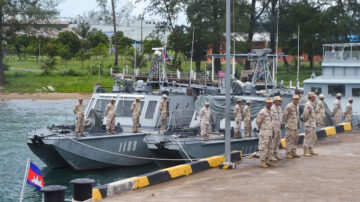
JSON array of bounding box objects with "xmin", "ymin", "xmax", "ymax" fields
[{"xmin": 283, "ymin": 94, "xmax": 300, "ymax": 159}]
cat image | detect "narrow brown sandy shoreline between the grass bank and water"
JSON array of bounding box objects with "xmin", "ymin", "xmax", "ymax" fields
[{"xmin": 0, "ymin": 93, "xmax": 91, "ymax": 101}]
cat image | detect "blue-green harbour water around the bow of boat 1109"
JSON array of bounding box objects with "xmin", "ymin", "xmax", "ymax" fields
[{"xmin": 0, "ymin": 100, "xmax": 159, "ymax": 202}]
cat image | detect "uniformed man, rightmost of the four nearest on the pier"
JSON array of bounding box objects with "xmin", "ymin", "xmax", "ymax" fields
[{"xmin": 302, "ymin": 92, "xmax": 317, "ymax": 157}]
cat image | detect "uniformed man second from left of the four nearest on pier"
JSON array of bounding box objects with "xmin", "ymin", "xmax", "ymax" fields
[{"xmin": 270, "ymin": 96, "xmax": 282, "ymax": 161}]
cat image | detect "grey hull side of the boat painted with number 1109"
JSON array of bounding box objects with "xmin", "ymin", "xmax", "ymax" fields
[{"xmin": 54, "ymin": 134, "xmax": 152, "ymax": 170}]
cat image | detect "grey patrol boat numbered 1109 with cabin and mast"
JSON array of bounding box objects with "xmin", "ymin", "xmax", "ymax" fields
[{"xmin": 27, "ymin": 49, "xmax": 195, "ymax": 170}]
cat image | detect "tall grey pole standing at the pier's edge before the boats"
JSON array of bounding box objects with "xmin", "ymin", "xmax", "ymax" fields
[{"xmin": 225, "ymin": 0, "xmax": 231, "ymax": 164}]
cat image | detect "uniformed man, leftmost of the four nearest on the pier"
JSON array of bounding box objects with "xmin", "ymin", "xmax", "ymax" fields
[{"xmin": 256, "ymin": 97, "xmax": 274, "ymax": 168}]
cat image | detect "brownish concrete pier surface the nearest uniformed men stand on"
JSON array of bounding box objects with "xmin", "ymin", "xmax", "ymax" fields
[{"xmin": 103, "ymin": 130, "xmax": 360, "ymax": 202}]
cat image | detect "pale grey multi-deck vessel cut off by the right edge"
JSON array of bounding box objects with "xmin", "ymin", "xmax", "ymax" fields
[{"xmin": 304, "ymin": 43, "xmax": 360, "ymax": 123}]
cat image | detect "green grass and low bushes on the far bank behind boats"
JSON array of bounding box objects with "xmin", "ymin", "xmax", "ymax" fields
[{"xmin": 3, "ymin": 55, "xmax": 321, "ymax": 93}]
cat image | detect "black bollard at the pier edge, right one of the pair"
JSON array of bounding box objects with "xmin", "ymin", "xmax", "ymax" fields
[{"xmin": 70, "ymin": 178, "xmax": 95, "ymax": 201}]
